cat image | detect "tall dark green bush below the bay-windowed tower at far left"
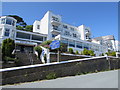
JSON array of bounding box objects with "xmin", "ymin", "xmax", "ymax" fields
[{"xmin": 2, "ymin": 38, "xmax": 15, "ymax": 60}]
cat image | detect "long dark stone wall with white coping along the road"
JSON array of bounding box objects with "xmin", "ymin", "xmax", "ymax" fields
[{"xmin": 0, "ymin": 57, "xmax": 120, "ymax": 84}]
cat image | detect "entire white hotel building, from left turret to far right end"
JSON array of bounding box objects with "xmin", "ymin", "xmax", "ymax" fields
[{"xmin": 0, "ymin": 11, "xmax": 116, "ymax": 56}]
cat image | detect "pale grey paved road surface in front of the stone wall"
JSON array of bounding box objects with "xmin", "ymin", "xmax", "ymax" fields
[{"xmin": 4, "ymin": 70, "xmax": 118, "ymax": 88}]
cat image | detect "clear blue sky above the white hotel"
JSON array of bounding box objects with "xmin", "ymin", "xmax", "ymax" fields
[{"xmin": 2, "ymin": 2, "xmax": 118, "ymax": 39}]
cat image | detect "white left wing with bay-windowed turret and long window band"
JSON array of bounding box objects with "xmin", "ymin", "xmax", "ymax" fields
[{"xmin": 0, "ymin": 16, "xmax": 47, "ymax": 51}]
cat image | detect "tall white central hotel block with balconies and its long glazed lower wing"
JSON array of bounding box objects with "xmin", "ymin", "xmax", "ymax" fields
[{"xmin": 33, "ymin": 11, "xmax": 108, "ymax": 56}]
